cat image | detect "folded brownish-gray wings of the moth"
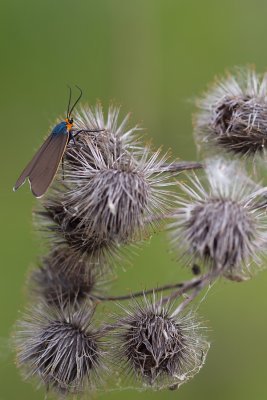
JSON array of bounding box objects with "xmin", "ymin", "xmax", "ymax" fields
[{"xmin": 14, "ymin": 133, "xmax": 69, "ymax": 197}]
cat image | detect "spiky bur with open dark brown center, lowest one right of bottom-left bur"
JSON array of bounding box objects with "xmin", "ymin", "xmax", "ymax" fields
[{"xmin": 114, "ymin": 297, "xmax": 209, "ymax": 389}]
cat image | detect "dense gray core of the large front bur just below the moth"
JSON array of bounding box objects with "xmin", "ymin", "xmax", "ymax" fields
[{"xmin": 62, "ymin": 169, "xmax": 151, "ymax": 243}]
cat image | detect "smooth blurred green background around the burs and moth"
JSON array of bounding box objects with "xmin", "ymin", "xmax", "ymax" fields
[{"xmin": 0, "ymin": 0, "xmax": 267, "ymax": 400}]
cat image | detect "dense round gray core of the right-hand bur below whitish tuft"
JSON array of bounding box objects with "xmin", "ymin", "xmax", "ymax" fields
[{"xmin": 185, "ymin": 198, "xmax": 255, "ymax": 268}]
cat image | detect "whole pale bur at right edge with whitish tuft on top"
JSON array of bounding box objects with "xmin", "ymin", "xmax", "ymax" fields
[{"xmin": 170, "ymin": 159, "xmax": 267, "ymax": 278}]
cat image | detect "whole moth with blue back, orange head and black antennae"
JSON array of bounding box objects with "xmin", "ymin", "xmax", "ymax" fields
[{"xmin": 13, "ymin": 89, "xmax": 85, "ymax": 197}]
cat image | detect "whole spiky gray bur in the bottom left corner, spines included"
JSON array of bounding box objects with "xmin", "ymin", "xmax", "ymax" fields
[{"xmin": 14, "ymin": 303, "xmax": 105, "ymax": 395}]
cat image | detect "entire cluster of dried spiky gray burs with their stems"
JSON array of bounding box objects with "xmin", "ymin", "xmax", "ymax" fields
[{"xmin": 15, "ymin": 69, "xmax": 267, "ymax": 397}]
